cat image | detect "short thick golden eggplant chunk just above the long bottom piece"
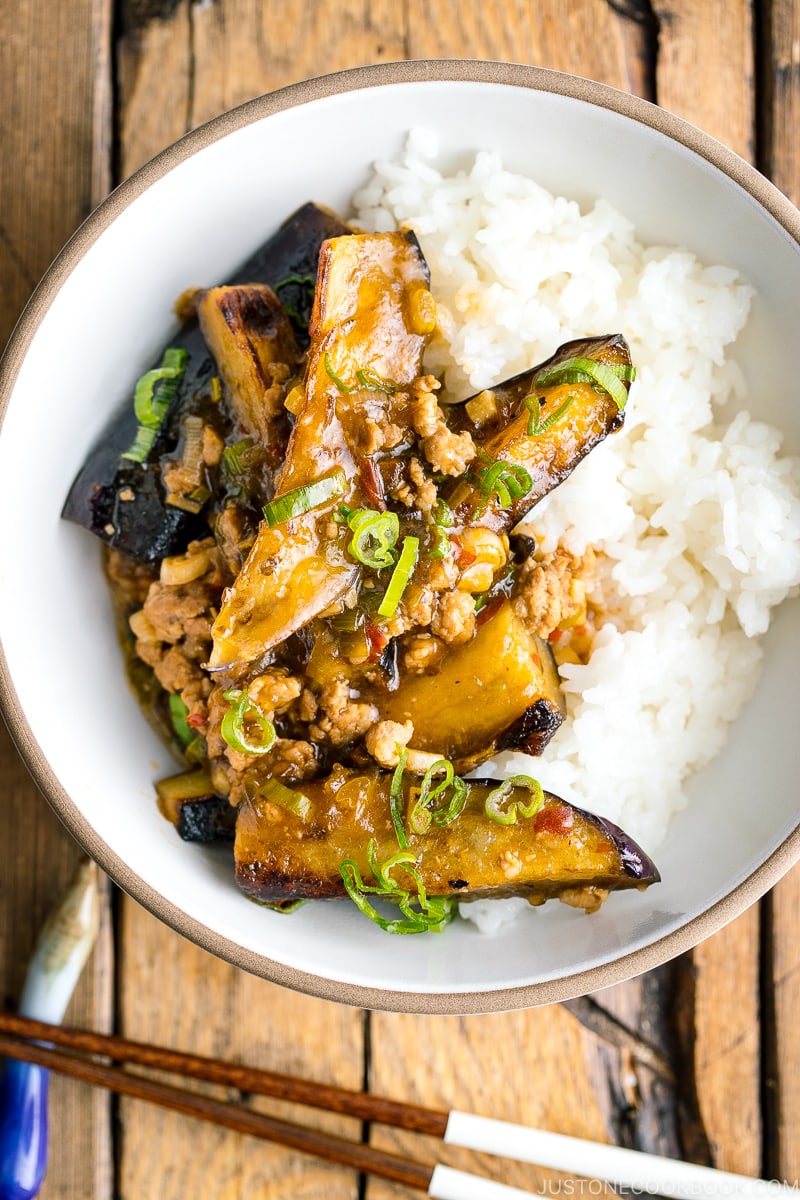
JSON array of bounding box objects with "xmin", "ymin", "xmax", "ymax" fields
[{"xmin": 369, "ymin": 600, "xmax": 566, "ymax": 772}]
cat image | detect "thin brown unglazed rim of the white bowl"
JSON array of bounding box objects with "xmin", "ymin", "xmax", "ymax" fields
[{"xmin": 0, "ymin": 59, "xmax": 800, "ymax": 1014}]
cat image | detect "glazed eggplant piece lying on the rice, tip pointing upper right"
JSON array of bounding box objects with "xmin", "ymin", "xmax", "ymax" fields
[{"xmin": 446, "ymin": 334, "xmax": 631, "ymax": 532}]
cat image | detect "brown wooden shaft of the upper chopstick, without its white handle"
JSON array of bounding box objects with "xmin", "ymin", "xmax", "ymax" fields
[{"xmin": 0, "ymin": 1013, "xmax": 449, "ymax": 1138}]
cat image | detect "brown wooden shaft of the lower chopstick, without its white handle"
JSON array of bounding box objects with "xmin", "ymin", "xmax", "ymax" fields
[{"xmin": 0, "ymin": 1015, "xmax": 434, "ymax": 1192}]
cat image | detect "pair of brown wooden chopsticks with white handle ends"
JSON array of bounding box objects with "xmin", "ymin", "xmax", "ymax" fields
[{"xmin": 0, "ymin": 1014, "xmax": 796, "ymax": 1200}]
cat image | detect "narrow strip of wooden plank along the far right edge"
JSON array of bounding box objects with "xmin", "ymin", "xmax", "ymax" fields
[{"xmin": 759, "ymin": 0, "xmax": 800, "ymax": 1183}]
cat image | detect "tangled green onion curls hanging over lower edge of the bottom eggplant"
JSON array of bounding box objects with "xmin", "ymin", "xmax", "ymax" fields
[{"xmin": 339, "ymin": 838, "xmax": 456, "ymax": 934}]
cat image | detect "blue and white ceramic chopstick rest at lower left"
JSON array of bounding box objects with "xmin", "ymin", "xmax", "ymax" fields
[{"xmin": 0, "ymin": 862, "xmax": 100, "ymax": 1200}]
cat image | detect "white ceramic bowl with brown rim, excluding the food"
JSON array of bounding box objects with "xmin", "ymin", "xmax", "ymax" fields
[{"xmin": 0, "ymin": 61, "xmax": 800, "ymax": 1013}]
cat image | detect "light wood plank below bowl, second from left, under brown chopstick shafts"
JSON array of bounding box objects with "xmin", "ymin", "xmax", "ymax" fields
[{"xmin": 118, "ymin": 902, "xmax": 363, "ymax": 1200}]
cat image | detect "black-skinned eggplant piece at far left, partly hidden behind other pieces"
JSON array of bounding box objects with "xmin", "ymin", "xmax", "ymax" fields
[{"xmin": 61, "ymin": 204, "xmax": 348, "ymax": 563}]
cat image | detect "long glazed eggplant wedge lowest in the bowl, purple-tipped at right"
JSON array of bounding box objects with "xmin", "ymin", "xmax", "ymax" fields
[{"xmin": 234, "ymin": 767, "xmax": 660, "ymax": 907}]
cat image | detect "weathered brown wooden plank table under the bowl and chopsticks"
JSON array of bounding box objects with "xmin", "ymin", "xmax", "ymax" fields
[{"xmin": 0, "ymin": 0, "xmax": 800, "ymax": 1200}]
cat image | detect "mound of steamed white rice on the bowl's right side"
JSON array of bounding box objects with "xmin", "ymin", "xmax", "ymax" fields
[{"xmin": 355, "ymin": 133, "xmax": 800, "ymax": 868}]
